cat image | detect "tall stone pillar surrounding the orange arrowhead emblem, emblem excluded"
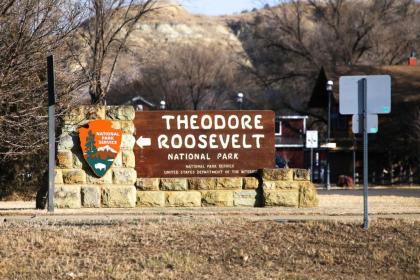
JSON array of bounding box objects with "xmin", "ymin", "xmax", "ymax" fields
[{"xmin": 54, "ymin": 106, "xmax": 137, "ymax": 208}]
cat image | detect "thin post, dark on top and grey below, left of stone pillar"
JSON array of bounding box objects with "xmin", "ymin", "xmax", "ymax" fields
[{"xmin": 47, "ymin": 55, "xmax": 55, "ymax": 212}]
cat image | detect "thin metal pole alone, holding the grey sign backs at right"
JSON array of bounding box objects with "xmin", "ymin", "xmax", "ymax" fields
[{"xmin": 363, "ymin": 79, "xmax": 369, "ymax": 229}]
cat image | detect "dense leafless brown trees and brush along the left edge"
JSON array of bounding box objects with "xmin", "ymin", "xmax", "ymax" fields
[{"xmin": 0, "ymin": 0, "xmax": 81, "ymax": 198}]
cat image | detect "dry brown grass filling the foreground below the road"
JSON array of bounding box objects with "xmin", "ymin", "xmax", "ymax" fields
[{"xmin": 0, "ymin": 219, "xmax": 420, "ymax": 279}]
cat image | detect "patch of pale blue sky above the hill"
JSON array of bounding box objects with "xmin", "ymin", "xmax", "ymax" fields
[{"xmin": 178, "ymin": 0, "xmax": 278, "ymax": 16}]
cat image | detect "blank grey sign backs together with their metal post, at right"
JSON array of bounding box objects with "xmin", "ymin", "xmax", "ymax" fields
[{"xmin": 340, "ymin": 75, "xmax": 391, "ymax": 229}]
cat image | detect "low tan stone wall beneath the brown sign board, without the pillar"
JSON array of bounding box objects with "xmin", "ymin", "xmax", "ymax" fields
[{"xmin": 136, "ymin": 169, "xmax": 318, "ymax": 207}]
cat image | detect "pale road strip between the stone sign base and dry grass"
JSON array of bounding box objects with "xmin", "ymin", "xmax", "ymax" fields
[{"xmin": 0, "ymin": 187, "xmax": 420, "ymax": 224}]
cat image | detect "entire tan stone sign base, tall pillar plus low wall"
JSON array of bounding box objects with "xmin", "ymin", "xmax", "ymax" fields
[{"xmin": 54, "ymin": 106, "xmax": 318, "ymax": 208}]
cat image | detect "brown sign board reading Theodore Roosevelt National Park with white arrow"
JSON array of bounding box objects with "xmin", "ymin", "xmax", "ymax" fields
[{"xmin": 134, "ymin": 111, "xmax": 275, "ymax": 178}]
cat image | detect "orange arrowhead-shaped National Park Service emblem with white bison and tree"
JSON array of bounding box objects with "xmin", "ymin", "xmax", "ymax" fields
[{"xmin": 79, "ymin": 120, "xmax": 122, "ymax": 177}]
